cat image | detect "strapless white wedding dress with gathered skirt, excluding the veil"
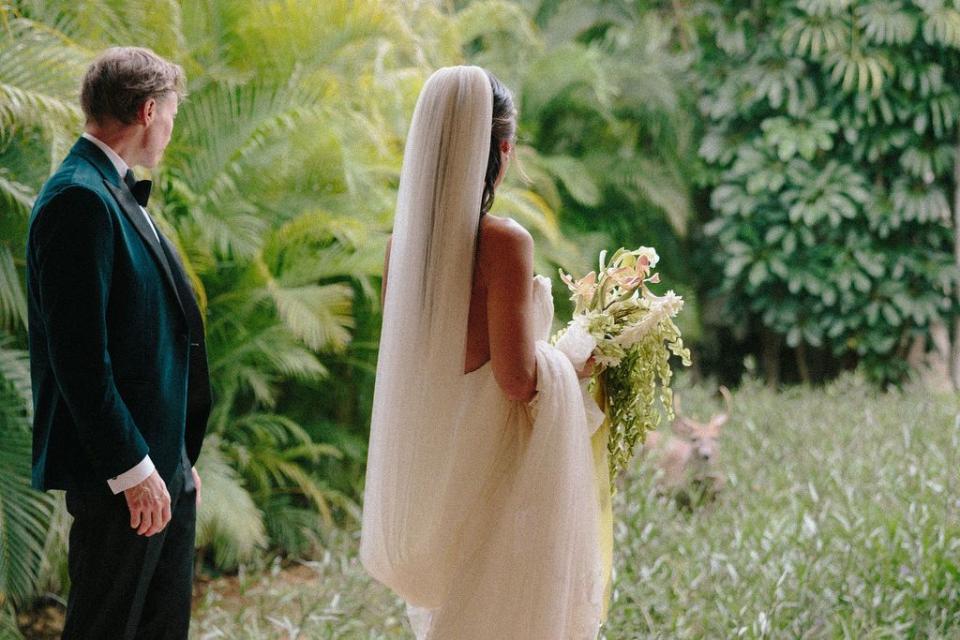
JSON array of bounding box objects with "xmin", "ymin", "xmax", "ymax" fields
[{"xmin": 366, "ymin": 276, "xmax": 602, "ymax": 640}]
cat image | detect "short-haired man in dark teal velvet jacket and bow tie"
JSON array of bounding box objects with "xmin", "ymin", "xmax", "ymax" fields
[{"xmin": 27, "ymin": 47, "xmax": 210, "ymax": 640}]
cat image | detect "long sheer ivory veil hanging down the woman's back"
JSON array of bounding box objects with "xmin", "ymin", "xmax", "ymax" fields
[{"xmin": 360, "ymin": 67, "xmax": 493, "ymax": 606}]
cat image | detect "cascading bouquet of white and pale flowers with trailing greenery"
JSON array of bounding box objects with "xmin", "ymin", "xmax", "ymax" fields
[{"xmin": 554, "ymin": 247, "xmax": 690, "ymax": 486}]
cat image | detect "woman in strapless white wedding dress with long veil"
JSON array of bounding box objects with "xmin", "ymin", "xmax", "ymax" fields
[{"xmin": 360, "ymin": 67, "xmax": 603, "ymax": 640}]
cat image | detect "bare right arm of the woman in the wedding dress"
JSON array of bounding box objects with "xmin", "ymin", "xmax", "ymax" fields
[{"xmin": 479, "ymin": 220, "xmax": 537, "ymax": 402}]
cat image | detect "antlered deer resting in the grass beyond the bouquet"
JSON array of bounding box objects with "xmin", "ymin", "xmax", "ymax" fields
[{"xmin": 643, "ymin": 385, "xmax": 733, "ymax": 511}]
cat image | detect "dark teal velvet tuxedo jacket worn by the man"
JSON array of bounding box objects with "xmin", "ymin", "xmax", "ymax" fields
[{"xmin": 27, "ymin": 138, "xmax": 211, "ymax": 492}]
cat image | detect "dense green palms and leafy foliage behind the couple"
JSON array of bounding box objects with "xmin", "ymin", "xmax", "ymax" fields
[{"xmin": 0, "ymin": 0, "xmax": 960, "ymax": 631}]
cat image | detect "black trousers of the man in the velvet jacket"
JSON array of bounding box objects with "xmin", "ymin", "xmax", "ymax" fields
[{"xmin": 62, "ymin": 469, "xmax": 197, "ymax": 640}]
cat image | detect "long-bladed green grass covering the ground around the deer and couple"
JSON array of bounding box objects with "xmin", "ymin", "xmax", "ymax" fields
[{"xmin": 192, "ymin": 377, "xmax": 960, "ymax": 640}]
